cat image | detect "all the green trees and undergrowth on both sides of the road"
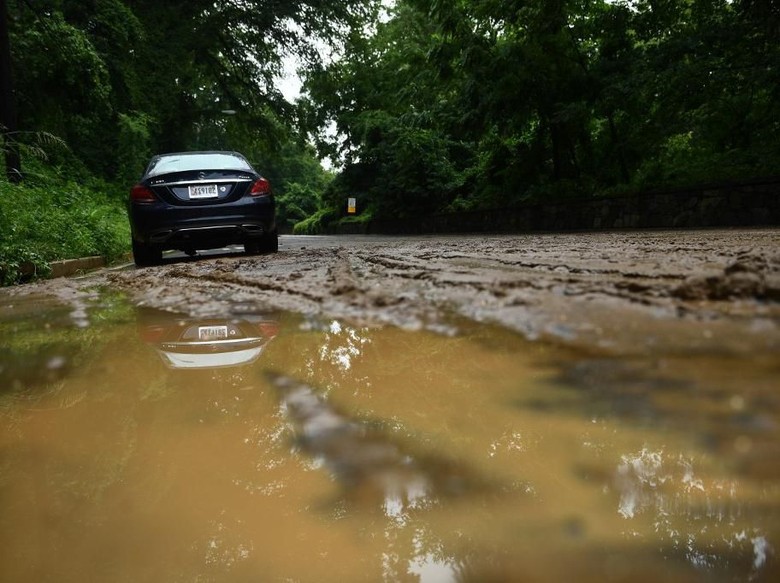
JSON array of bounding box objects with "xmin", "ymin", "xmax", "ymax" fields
[{"xmin": 0, "ymin": 0, "xmax": 780, "ymax": 283}]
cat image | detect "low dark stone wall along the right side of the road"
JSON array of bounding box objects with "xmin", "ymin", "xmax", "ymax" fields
[{"xmin": 334, "ymin": 178, "xmax": 780, "ymax": 234}]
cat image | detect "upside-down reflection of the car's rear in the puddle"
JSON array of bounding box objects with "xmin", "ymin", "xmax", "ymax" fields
[{"xmin": 138, "ymin": 309, "xmax": 279, "ymax": 369}]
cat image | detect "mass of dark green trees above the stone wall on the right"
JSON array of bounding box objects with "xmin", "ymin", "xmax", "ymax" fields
[{"xmin": 303, "ymin": 0, "xmax": 780, "ymax": 226}]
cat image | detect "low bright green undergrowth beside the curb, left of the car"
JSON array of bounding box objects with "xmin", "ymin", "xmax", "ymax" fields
[{"xmin": 0, "ymin": 178, "xmax": 130, "ymax": 285}]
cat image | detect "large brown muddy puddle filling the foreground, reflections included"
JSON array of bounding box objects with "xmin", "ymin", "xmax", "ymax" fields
[{"xmin": 0, "ymin": 294, "xmax": 780, "ymax": 582}]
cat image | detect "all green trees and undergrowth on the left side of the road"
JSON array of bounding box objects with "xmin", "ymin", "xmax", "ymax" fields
[{"xmin": 0, "ymin": 0, "xmax": 378, "ymax": 272}]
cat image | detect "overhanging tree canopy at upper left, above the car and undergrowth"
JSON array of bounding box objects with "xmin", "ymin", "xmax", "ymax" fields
[{"xmin": 8, "ymin": 0, "xmax": 376, "ymax": 180}]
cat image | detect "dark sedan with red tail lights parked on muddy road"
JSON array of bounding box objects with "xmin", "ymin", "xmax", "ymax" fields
[{"xmin": 128, "ymin": 152, "xmax": 279, "ymax": 266}]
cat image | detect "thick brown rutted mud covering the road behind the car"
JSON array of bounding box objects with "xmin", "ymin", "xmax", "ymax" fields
[{"xmin": 15, "ymin": 229, "xmax": 780, "ymax": 354}]
